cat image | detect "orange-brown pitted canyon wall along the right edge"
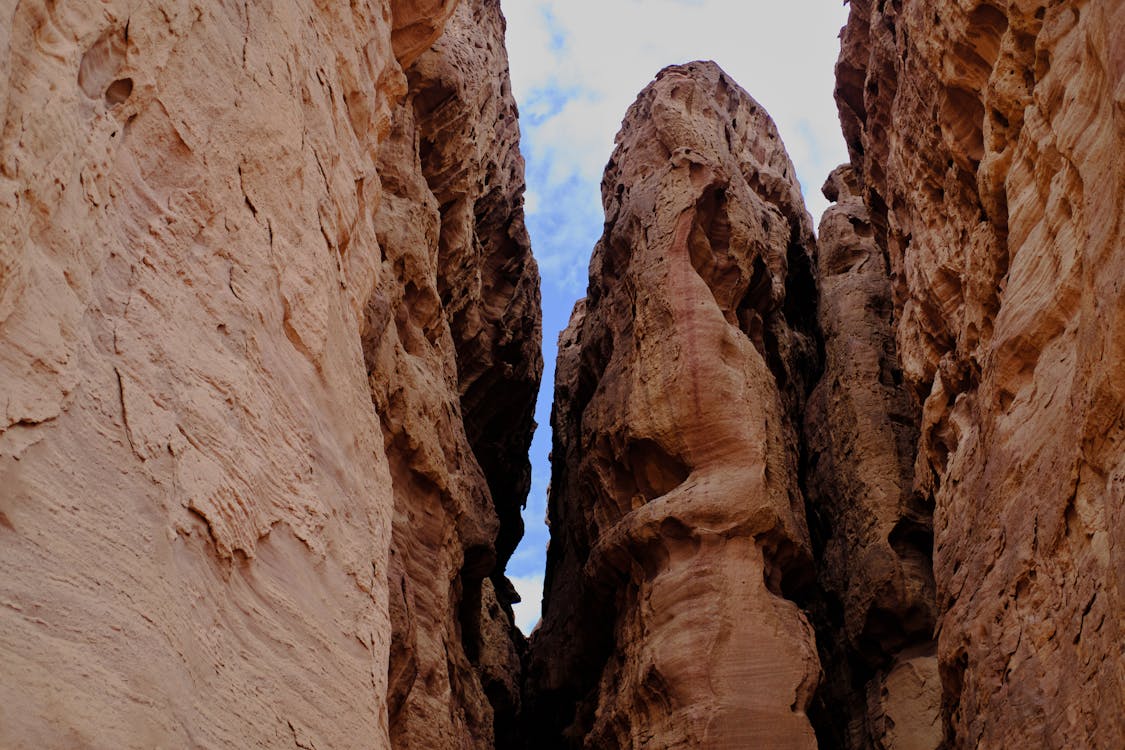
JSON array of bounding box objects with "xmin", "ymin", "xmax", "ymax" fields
[{"xmin": 837, "ymin": 0, "xmax": 1125, "ymax": 748}]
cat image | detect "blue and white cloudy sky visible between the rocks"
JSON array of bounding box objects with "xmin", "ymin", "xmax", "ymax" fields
[{"xmin": 503, "ymin": 0, "xmax": 847, "ymax": 633}]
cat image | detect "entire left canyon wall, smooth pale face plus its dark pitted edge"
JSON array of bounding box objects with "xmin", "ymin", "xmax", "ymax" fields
[{"xmin": 0, "ymin": 0, "xmax": 540, "ymax": 748}]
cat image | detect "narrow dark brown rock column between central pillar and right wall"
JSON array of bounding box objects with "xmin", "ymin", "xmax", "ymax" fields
[{"xmin": 804, "ymin": 166, "xmax": 942, "ymax": 749}]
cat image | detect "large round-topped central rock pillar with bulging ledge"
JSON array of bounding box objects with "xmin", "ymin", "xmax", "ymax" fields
[{"xmin": 527, "ymin": 63, "xmax": 820, "ymax": 748}]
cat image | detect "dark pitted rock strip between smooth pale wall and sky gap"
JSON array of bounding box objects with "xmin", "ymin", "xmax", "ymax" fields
[{"xmin": 363, "ymin": 0, "xmax": 542, "ymax": 748}]
